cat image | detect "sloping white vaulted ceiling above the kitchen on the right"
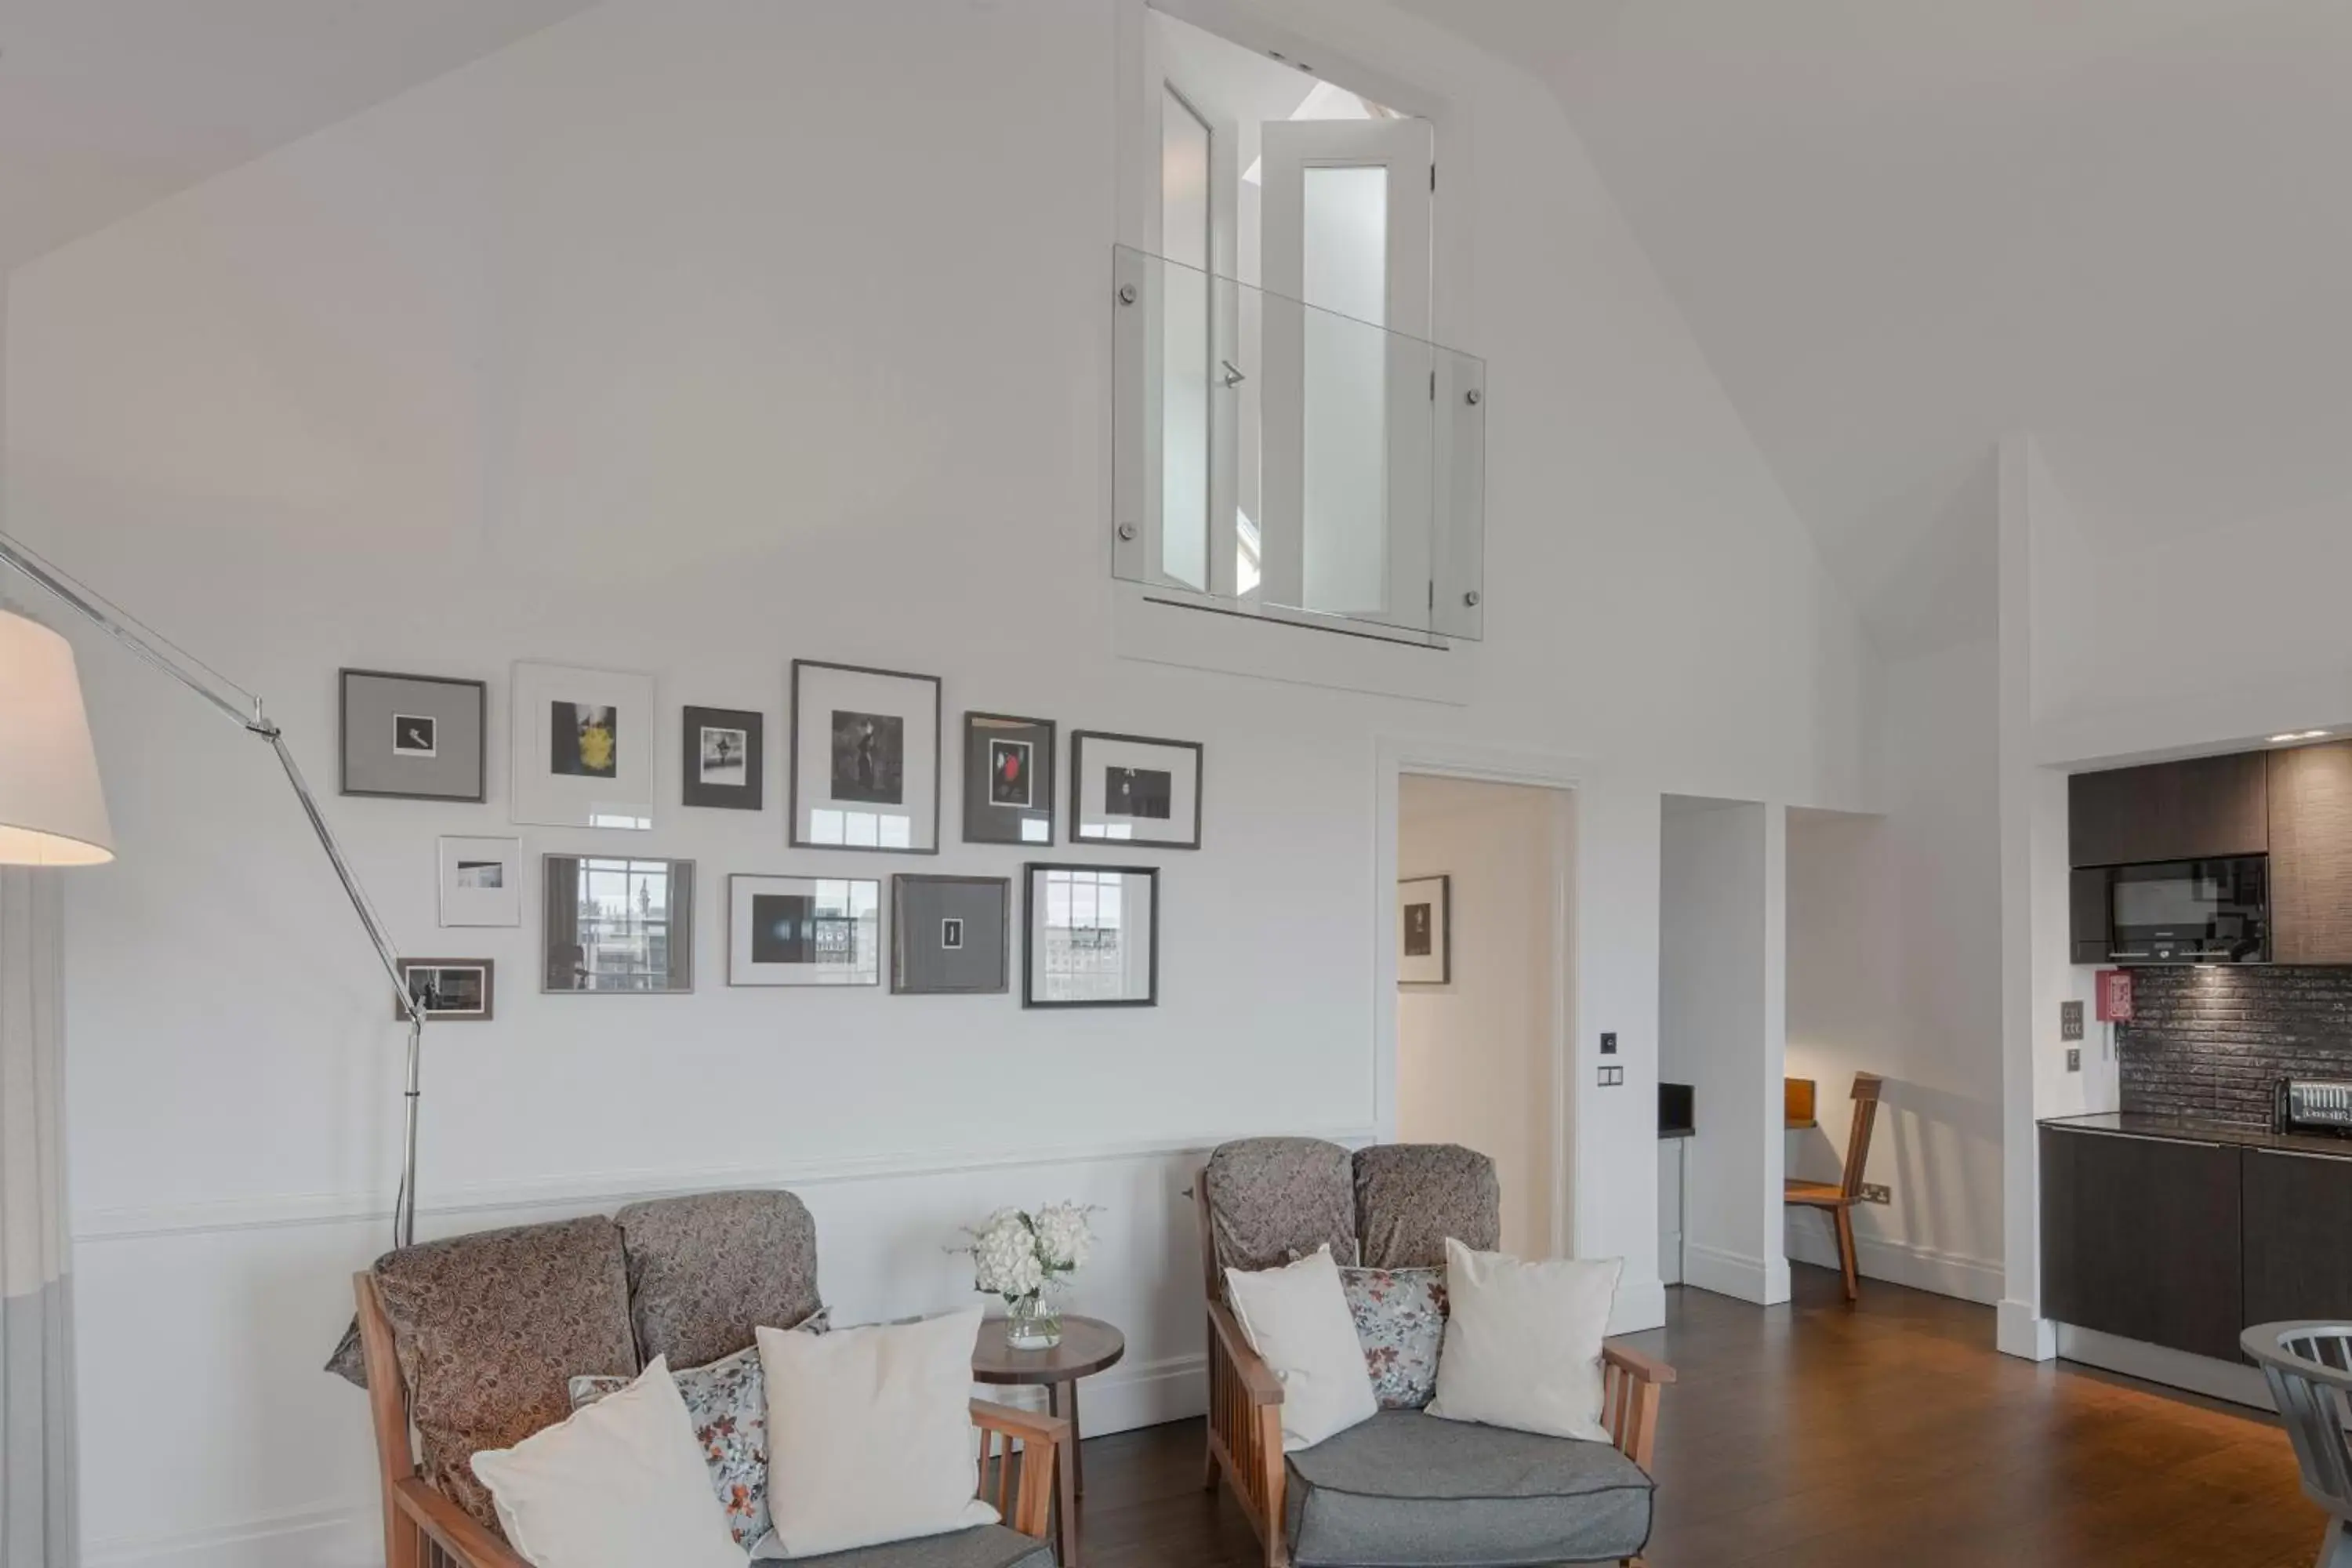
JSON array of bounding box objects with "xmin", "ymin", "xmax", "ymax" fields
[{"xmin": 1402, "ymin": 0, "xmax": 2352, "ymax": 652}]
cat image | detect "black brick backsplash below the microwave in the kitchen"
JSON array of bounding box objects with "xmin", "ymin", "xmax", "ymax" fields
[{"xmin": 2114, "ymin": 964, "xmax": 2352, "ymax": 1131}]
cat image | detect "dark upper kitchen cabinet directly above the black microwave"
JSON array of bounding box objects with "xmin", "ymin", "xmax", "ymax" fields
[{"xmin": 2067, "ymin": 753, "xmax": 2270, "ymax": 865}]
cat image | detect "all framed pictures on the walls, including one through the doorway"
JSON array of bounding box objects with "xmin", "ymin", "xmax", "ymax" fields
[{"xmin": 339, "ymin": 659, "xmax": 1204, "ymax": 1022}]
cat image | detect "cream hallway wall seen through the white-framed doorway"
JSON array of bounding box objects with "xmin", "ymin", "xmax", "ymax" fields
[{"xmin": 1397, "ymin": 774, "xmax": 1569, "ymax": 1258}]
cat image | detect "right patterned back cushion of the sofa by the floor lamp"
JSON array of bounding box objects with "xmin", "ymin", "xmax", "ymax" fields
[{"xmin": 621, "ymin": 1192, "xmax": 821, "ymax": 1370}]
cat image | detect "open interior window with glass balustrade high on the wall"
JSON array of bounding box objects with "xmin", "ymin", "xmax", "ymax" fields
[{"xmin": 1112, "ymin": 7, "xmax": 1484, "ymax": 640}]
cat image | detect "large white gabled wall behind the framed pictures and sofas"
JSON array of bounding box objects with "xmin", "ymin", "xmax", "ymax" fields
[{"xmin": 5, "ymin": 0, "xmax": 1863, "ymax": 1568}]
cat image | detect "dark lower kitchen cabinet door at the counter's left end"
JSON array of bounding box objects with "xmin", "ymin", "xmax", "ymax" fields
[{"xmin": 2042, "ymin": 1126, "xmax": 2251, "ymax": 1359}]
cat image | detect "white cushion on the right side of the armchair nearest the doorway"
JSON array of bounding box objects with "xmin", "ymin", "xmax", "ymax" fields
[{"xmin": 1430, "ymin": 1236, "xmax": 1625, "ymax": 1443}]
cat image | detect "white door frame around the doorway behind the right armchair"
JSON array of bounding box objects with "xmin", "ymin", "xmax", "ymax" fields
[{"xmin": 1371, "ymin": 736, "xmax": 1590, "ymax": 1258}]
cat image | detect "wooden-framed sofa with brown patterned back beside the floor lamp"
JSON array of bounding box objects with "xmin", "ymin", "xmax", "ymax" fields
[{"xmin": 332, "ymin": 1192, "xmax": 1070, "ymax": 1568}]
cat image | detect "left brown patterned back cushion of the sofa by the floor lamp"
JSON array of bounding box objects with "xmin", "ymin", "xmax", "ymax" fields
[{"xmin": 374, "ymin": 1215, "xmax": 637, "ymax": 1530}]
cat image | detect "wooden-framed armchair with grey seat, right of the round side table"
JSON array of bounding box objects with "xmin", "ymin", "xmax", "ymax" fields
[{"xmin": 1192, "ymin": 1138, "xmax": 1675, "ymax": 1568}]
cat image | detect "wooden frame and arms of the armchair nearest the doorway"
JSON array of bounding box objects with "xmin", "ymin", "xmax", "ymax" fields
[{"xmin": 1192, "ymin": 1171, "xmax": 1675, "ymax": 1568}]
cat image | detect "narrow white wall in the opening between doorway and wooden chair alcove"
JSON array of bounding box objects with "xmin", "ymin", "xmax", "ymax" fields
[{"xmin": 1649, "ymin": 797, "xmax": 1788, "ymax": 1302}]
